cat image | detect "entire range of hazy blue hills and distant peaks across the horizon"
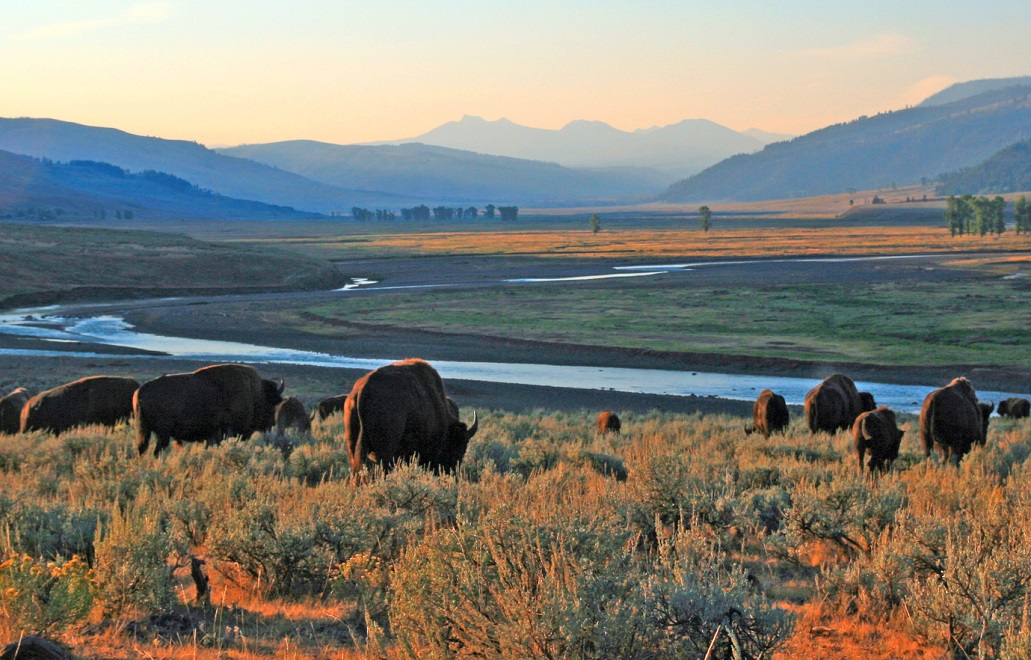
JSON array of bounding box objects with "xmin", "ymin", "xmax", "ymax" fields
[{"xmin": 0, "ymin": 77, "xmax": 1031, "ymax": 218}]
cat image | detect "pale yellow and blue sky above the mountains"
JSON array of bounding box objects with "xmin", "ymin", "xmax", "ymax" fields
[{"xmin": 0, "ymin": 0, "xmax": 1031, "ymax": 146}]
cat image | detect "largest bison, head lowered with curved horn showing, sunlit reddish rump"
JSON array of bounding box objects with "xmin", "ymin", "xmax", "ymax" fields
[{"xmin": 344, "ymin": 359, "xmax": 477, "ymax": 474}]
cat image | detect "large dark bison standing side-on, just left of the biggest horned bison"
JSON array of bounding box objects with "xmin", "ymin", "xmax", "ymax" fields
[{"xmin": 133, "ymin": 364, "xmax": 284, "ymax": 456}]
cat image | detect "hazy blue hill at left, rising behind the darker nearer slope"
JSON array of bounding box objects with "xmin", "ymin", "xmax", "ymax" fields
[{"xmin": 0, "ymin": 119, "xmax": 406, "ymax": 212}]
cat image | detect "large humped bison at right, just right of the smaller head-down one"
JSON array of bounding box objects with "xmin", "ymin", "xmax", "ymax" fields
[{"xmin": 920, "ymin": 377, "xmax": 991, "ymax": 465}]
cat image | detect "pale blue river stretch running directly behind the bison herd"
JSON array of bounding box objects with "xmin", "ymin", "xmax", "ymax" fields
[{"xmin": 0, "ymin": 309, "xmax": 1028, "ymax": 413}]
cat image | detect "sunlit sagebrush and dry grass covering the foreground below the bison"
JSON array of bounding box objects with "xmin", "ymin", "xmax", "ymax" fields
[{"xmin": 0, "ymin": 411, "xmax": 1031, "ymax": 658}]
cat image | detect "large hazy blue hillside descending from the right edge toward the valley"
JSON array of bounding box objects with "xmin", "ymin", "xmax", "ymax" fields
[{"xmin": 659, "ymin": 86, "xmax": 1031, "ymax": 203}]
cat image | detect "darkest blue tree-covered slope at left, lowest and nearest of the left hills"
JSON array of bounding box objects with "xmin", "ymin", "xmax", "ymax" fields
[{"xmin": 0, "ymin": 151, "xmax": 314, "ymax": 220}]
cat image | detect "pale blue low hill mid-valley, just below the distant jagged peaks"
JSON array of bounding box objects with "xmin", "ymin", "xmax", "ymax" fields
[{"xmin": 219, "ymin": 140, "xmax": 669, "ymax": 205}]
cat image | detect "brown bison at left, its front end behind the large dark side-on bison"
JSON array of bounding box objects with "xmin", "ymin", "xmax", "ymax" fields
[{"xmin": 20, "ymin": 375, "xmax": 139, "ymax": 433}]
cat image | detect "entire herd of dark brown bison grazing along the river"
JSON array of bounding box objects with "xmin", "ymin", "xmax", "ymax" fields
[{"xmin": 0, "ymin": 359, "xmax": 1031, "ymax": 475}]
